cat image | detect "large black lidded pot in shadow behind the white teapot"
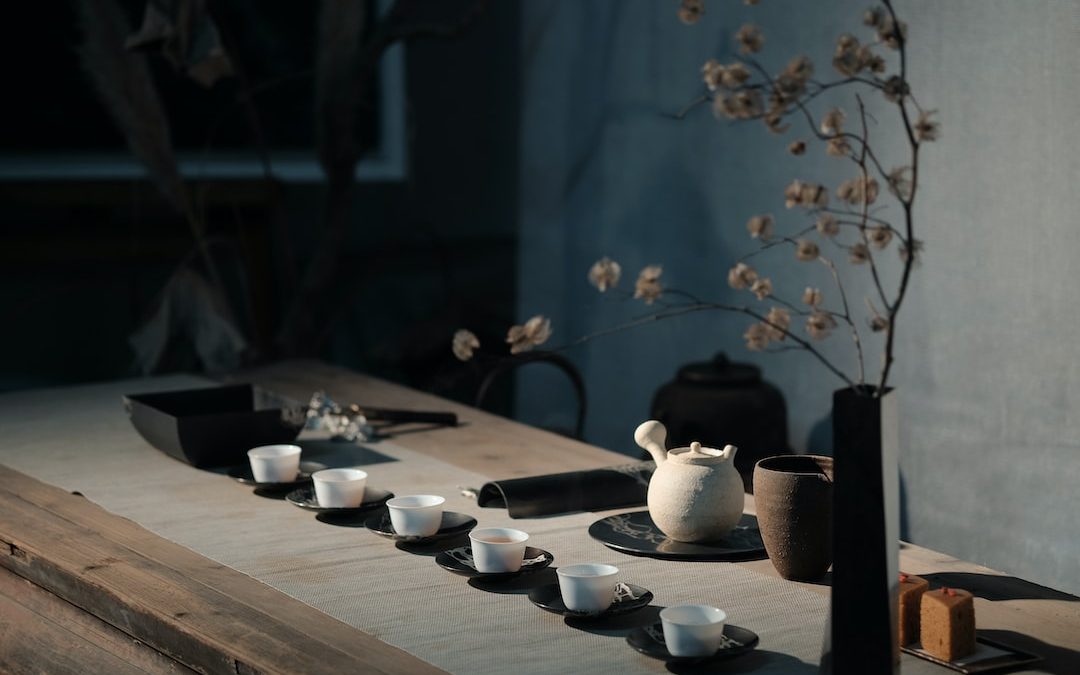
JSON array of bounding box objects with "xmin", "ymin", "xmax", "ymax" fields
[{"xmin": 652, "ymin": 352, "xmax": 792, "ymax": 492}]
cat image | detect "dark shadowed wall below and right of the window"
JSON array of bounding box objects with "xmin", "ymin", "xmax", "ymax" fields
[{"xmin": 0, "ymin": 2, "xmax": 517, "ymax": 406}]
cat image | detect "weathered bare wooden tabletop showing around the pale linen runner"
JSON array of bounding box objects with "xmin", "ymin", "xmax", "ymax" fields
[{"xmin": 0, "ymin": 362, "xmax": 1080, "ymax": 673}]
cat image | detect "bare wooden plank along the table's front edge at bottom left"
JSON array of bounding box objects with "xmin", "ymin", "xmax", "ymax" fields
[{"xmin": 0, "ymin": 467, "xmax": 442, "ymax": 674}]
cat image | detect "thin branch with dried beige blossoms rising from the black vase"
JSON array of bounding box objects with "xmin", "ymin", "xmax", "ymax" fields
[{"xmin": 455, "ymin": 0, "xmax": 939, "ymax": 395}]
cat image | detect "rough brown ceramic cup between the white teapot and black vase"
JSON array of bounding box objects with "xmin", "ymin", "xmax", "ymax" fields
[{"xmin": 754, "ymin": 455, "xmax": 833, "ymax": 581}]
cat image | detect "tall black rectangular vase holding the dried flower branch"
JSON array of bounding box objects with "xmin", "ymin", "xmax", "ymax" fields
[{"xmin": 822, "ymin": 387, "xmax": 900, "ymax": 675}]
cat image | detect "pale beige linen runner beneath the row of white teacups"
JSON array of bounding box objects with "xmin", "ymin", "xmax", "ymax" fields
[{"xmin": 0, "ymin": 377, "xmax": 825, "ymax": 674}]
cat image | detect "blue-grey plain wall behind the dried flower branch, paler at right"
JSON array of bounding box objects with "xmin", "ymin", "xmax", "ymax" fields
[{"xmin": 518, "ymin": 0, "xmax": 1080, "ymax": 593}]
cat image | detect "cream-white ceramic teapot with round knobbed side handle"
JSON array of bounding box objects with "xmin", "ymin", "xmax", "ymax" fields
[{"xmin": 634, "ymin": 420, "xmax": 744, "ymax": 542}]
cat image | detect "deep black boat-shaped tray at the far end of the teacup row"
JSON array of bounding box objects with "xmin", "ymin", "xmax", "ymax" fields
[{"xmin": 123, "ymin": 384, "xmax": 307, "ymax": 469}]
